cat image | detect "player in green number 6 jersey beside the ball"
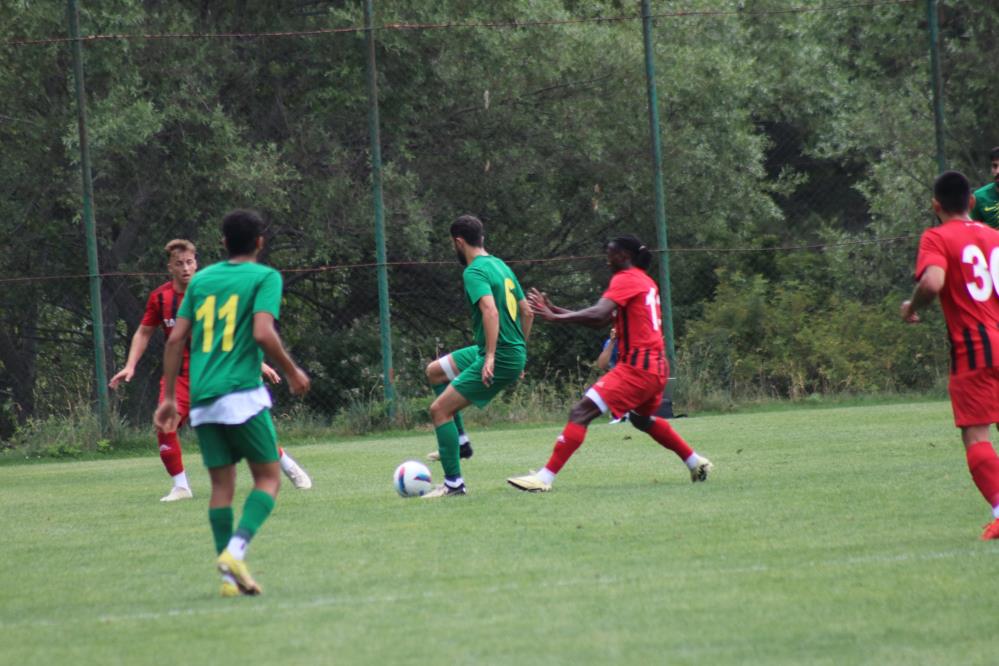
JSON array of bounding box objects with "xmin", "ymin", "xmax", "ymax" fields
[{"xmin": 424, "ymin": 215, "xmax": 534, "ymax": 498}]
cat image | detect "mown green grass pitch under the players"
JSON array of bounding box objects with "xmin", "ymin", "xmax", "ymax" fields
[{"xmin": 0, "ymin": 403, "xmax": 999, "ymax": 664}]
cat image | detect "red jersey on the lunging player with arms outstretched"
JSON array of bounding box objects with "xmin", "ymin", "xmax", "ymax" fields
[{"xmin": 603, "ymin": 268, "xmax": 666, "ymax": 376}]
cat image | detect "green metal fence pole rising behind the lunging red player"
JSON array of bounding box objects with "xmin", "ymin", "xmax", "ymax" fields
[{"xmin": 642, "ymin": 0, "xmax": 676, "ymax": 365}]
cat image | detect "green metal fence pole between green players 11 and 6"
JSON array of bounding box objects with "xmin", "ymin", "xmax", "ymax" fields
[{"xmin": 364, "ymin": 0, "xmax": 395, "ymax": 419}]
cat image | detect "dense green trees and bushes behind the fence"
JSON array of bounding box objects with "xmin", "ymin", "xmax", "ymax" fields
[{"xmin": 0, "ymin": 0, "xmax": 999, "ymax": 437}]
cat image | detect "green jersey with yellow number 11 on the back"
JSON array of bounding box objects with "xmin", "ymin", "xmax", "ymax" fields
[{"xmin": 177, "ymin": 261, "xmax": 282, "ymax": 406}]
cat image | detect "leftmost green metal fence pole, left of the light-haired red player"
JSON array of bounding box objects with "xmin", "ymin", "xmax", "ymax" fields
[{"xmin": 67, "ymin": 0, "xmax": 111, "ymax": 433}]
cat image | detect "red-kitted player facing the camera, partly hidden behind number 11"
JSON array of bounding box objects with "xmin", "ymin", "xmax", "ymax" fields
[{"xmin": 109, "ymin": 239, "xmax": 312, "ymax": 502}]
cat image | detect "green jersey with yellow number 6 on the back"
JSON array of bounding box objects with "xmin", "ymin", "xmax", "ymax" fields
[{"xmin": 462, "ymin": 254, "xmax": 527, "ymax": 355}]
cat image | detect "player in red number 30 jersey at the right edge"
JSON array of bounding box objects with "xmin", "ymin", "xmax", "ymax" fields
[{"xmin": 901, "ymin": 171, "xmax": 999, "ymax": 540}]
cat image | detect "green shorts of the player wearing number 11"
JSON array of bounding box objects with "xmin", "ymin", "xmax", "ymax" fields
[{"xmin": 194, "ymin": 409, "xmax": 278, "ymax": 469}]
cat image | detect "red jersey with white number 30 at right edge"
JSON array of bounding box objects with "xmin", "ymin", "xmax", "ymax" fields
[{"xmin": 915, "ymin": 220, "xmax": 999, "ymax": 373}]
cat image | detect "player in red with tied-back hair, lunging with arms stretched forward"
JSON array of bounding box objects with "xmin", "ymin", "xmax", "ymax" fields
[{"xmin": 507, "ymin": 236, "xmax": 714, "ymax": 492}]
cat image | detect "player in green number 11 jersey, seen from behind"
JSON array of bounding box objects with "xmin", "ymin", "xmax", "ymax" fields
[{"xmin": 154, "ymin": 210, "xmax": 309, "ymax": 596}]
